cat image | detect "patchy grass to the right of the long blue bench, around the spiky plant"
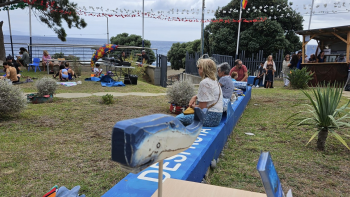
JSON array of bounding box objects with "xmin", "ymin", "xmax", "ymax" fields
[{"xmin": 207, "ymin": 81, "xmax": 350, "ymax": 196}]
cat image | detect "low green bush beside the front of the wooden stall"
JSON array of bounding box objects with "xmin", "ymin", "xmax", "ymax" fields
[{"xmin": 287, "ymin": 67, "xmax": 314, "ymax": 89}]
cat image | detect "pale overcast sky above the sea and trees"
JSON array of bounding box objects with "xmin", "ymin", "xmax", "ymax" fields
[{"xmin": 0, "ymin": 0, "xmax": 350, "ymax": 43}]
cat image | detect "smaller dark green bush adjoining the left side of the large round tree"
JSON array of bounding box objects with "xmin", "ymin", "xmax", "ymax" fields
[{"xmin": 167, "ymin": 39, "xmax": 201, "ymax": 70}]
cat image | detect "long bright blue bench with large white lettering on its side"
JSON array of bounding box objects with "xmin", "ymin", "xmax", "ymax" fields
[{"xmin": 103, "ymin": 86, "xmax": 251, "ymax": 197}]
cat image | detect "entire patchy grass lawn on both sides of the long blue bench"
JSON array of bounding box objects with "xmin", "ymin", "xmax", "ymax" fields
[{"xmin": 0, "ymin": 72, "xmax": 350, "ymax": 197}]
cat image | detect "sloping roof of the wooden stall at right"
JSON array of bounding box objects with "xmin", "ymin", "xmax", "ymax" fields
[{"xmin": 295, "ymin": 25, "xmax": 350, "ymax": 41}]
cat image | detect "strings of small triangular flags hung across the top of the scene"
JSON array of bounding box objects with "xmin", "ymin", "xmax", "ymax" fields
[{"xmin": 0, "ymin": 0, "xmax": 350, "ymax": 21}]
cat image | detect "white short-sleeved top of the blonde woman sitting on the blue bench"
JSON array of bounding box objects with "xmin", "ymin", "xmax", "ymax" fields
[{"xmin": 197, "ymin": 78, "xmax": 223, "ymax": 112}]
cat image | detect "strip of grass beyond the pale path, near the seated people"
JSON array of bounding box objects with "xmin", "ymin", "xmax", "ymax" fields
[{"xmin": 18, "ymin": 69, "xmax": 166, "ymax": 93}]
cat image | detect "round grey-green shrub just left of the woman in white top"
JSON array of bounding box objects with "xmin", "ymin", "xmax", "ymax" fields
[{"xmin": 167, "ymin": 80, "xmax": 195, "ymax": 106}]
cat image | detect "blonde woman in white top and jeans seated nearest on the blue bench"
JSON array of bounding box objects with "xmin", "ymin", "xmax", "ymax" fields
[{"xmin": 176, "ymin": 59, "xmax": 223, "ymax": 127}]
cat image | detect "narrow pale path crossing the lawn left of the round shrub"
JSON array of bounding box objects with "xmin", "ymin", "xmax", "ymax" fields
[{"xmin": 54, "ymin": 92, "xmax": 166, "ymax": 98}]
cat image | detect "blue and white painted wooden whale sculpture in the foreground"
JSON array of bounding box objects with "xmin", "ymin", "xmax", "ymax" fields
[{"xmin": 112, "ymin": 108, "xmax": 207, "ymax": 173}]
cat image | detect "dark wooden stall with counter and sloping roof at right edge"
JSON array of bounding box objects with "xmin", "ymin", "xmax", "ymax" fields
[{"xmin": 296, "ymin": 25, "xmax": 350, "ymax": 86}]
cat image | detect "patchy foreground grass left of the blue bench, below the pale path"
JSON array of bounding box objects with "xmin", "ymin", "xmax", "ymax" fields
[{"xmin": 0, "ymin": 96, "xmax": 168, "ymax": 197}]
